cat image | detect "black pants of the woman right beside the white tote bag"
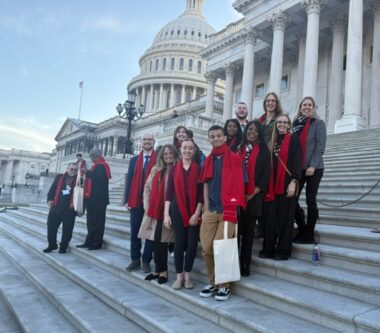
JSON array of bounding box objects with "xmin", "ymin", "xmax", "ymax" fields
[{"xmin": 238, "ymin": 211, "xmax": 258, "ymax": 266}]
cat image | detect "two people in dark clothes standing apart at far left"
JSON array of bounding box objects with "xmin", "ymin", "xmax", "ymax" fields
[{"xmin": 43, "ymin": 148, "xmax": 111, "ymax": 254}]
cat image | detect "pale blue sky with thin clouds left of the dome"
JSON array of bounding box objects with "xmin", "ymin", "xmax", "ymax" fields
[{"xmin": 0, "ymin": 0, "xmax": 240, "ymax": 151}]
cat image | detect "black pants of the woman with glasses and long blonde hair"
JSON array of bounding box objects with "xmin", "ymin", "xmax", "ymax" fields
[{"xmin": 263, "ymin": 194, "xmax": 297, "ymax": 259}]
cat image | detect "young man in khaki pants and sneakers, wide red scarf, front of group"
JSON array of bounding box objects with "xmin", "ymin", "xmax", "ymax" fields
[{"xmin": 200, "ymin": 125, "xmax": 246, "ymax": 301}]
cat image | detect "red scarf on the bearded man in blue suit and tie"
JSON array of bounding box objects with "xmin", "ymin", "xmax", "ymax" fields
[{"xmin": 128, "ymin": 150, "xmax": 157, "ymax": 208}]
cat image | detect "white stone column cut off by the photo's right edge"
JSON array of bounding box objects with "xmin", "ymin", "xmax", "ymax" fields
[{"xmin": 370, "ymin": 0, "xmax": 380, "ymax": 127}]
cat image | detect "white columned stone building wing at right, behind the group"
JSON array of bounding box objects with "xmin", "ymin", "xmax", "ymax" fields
[{"xmin": 201, "ymin": 0, "xmax": 380, "ymax": 133}]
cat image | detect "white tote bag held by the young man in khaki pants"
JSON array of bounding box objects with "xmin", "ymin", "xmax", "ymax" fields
[{"xmin": 214, "ymin": 222, "xmax": 240, "ymax": 285}]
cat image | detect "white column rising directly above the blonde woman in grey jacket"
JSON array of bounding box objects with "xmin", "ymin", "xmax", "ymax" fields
[{"xmin": 303, "ymin": 0, "xmax": 326, "ymax": 98}]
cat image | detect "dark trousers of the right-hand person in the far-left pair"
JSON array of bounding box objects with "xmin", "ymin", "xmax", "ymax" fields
[{"xmin": 85, "ymin": 205, "xmax": 107, "ymax": 248}]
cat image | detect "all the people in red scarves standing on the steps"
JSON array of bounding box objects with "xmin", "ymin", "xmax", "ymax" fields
[{"xmin": 45, "ymin": 92, "xmax": 326, "ymax": 301}]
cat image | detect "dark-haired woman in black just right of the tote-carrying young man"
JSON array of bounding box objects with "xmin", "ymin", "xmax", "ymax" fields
[{"xmin": 238, "ymin": 120, "xmax": 270, "ymax": 276}]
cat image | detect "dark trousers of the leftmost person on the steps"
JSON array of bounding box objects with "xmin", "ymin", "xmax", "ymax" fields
[{"xmin": 47, "ymin": 210, "xmax": 75, "ymax": 249}]
